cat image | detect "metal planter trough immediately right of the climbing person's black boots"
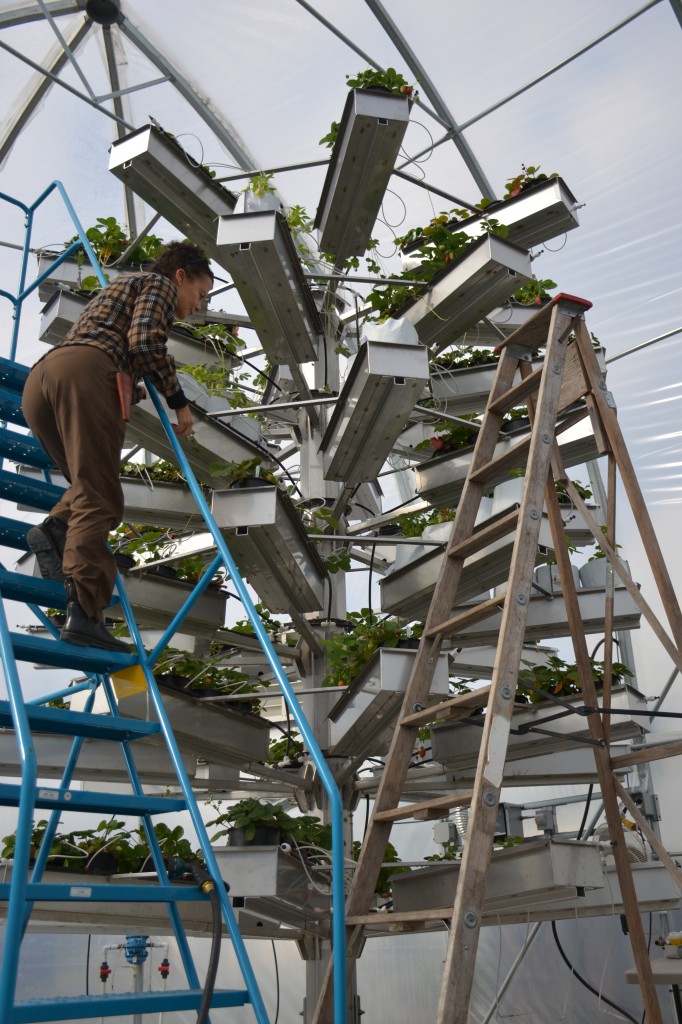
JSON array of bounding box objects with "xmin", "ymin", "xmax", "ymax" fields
[{"xmin": 106, "ymin": 571, "xmax": 227, "ymax": 637}]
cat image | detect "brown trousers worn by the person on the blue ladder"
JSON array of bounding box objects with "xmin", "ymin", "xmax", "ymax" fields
[{"xmin": 23, "ymin": 345, "xmax": 125, "ymax": 621}]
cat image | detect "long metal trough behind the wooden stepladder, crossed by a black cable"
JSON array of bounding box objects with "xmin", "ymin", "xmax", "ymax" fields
[{"xmin": 431, "ymin": 683, "xmax": 646, "ymax": 771}]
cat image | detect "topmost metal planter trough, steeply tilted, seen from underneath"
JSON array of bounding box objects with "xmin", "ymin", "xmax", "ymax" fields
[{"xmin": 314, "ymin": 89, "xmax": 411, "ymax": 261}]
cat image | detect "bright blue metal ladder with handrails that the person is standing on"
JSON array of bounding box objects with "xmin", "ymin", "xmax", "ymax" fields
[{"xmin": 0, "ymin": 182, "xmax": 346, "ymax": 1024}]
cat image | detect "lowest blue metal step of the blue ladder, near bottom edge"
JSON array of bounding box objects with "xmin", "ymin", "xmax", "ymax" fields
[{"xmin": 5, "ymin": 988, "xmax": 250, "ymax": 1024}]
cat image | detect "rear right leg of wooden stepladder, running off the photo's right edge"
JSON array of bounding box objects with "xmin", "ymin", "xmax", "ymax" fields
[{"xmin": 576, "ymin": 324, "xmax": 682, "ymax": 651}]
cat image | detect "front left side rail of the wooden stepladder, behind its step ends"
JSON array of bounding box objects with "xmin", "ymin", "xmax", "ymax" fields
[{"xmin": 312, "ymin": 350, "xmax": 518, "ymax": 1024}]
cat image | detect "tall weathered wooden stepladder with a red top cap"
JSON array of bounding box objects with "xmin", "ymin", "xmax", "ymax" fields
[{"xmin": 313, "ymin": 295, "xmax": 682, "ymax": 1024}]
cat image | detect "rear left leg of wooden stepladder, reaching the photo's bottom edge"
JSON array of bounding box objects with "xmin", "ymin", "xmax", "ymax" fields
[{"xmin": 536, "ymin": 432, "xmax": 663, "ymax": 1024}]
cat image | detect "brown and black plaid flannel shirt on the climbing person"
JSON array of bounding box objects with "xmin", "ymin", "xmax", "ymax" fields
[{"xmin": 56, "ymin": 273, "xmax": 187, "ymax": 409}]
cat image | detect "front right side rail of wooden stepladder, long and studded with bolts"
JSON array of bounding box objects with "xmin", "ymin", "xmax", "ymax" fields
[{"xmin": 436, "ymin": 296, "xmax": 574, "ymax": 1024}]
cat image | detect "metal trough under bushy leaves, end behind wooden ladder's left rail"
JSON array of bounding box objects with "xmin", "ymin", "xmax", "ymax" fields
[{"xmin": 329, "ymin": 647, "xmax": 449, "ymax": 757}]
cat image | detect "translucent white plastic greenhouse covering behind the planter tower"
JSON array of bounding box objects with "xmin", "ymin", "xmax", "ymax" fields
[{"xmin": 0, "ymin": 0, "xmax": 682, "ymax": 1024}]
